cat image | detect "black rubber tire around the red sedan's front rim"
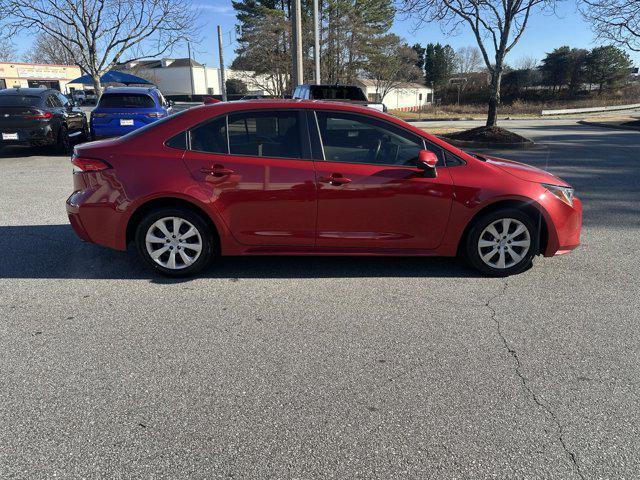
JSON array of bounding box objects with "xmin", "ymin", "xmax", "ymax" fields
[{"xmin": 465, "ymin": 208, "xmax": 540, "ymax": 277}]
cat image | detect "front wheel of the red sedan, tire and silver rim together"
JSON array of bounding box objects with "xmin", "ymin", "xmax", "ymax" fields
[{"xmin": 466, "ymin": 208, "xmax": 539, "ymax": 277}]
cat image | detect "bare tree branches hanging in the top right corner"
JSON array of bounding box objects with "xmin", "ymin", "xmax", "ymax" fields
[{"xmin": 581, "ymin": 0, "xmax": 640, "ymax": 52}]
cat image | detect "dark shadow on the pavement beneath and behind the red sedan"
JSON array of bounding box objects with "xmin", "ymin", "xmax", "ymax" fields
[{"xmin": 0, "ymin": 225, "xmax": 478, "ymax": 283}]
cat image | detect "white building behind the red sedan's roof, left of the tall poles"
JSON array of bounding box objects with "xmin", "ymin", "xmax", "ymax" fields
[{"xmin": 119, "ymin": 58, "xmax": 276, "ymax": 95}]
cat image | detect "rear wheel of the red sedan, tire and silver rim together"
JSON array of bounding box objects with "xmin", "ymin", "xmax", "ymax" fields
[{"xmin": 136, "ymin": 207, "xmax": 215, "ymax": 277}]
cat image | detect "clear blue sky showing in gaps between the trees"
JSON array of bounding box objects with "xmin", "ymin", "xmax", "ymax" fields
[{"xmin": 10, "ymin": 0, "xmax": 640, "ymax": 66}]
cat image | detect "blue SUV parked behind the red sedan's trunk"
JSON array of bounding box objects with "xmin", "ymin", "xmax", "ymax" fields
[{"xmin": 91, "ymin": 87, "xmax": 173, "ymax": 140}]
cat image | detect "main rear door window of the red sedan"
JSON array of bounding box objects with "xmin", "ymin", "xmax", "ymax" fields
[{"xmin": 228, "ymin": 110, "xmax": 302, "ymax": 158}]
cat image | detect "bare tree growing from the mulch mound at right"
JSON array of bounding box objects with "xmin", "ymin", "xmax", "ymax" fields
[{"xmin": 402, "ymin": 0, "xmax": 555, "ymax": 127}]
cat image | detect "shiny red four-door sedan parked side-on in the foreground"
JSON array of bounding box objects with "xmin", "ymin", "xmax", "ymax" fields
[{"xmin": 67, "ymin": 100, "xmax": 582, "ymax": 276}]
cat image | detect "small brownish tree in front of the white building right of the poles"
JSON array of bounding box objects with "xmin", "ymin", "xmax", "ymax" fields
[{"xmin": 364, "ymin": 34, "xmax": 422, "ymax": 102}]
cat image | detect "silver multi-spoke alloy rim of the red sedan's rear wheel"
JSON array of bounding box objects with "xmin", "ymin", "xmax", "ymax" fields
[{"xmin": 145, "ymin": 217, "xmax": 202, "ymax": 270}]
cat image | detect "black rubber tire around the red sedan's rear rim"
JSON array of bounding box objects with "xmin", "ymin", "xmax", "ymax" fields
[{"xmin": 135, "ymin": 207, "xmax": 217, "ymax": 277}]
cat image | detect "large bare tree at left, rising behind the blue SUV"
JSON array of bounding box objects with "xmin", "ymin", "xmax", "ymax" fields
[{"xmin": 0, "ymin": 0, "xmax": 197, "ymax": 95}]
